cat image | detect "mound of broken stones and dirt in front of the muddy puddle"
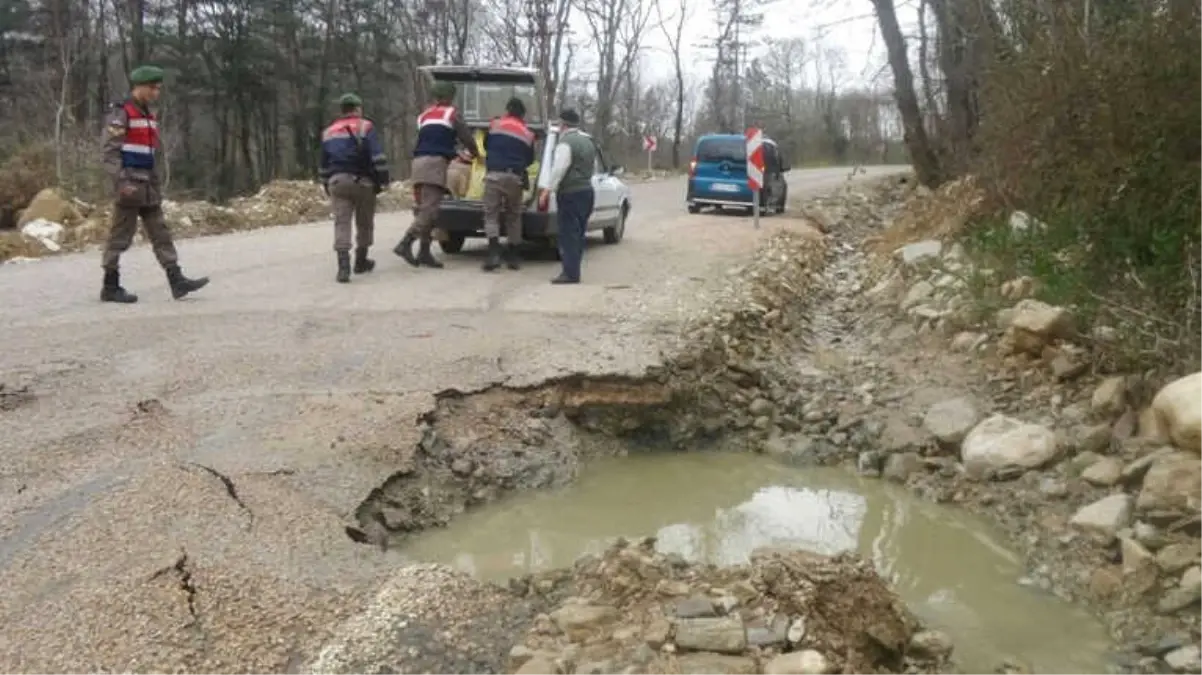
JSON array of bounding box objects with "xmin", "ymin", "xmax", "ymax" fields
[{"xmin": 510, "ymin": 539, "xmax": 954, "ymax": 675}]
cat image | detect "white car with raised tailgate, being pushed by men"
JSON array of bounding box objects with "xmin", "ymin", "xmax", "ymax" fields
[{"xmin": 421, "ymin": 66, "xmax": 631, "ymax": 253}]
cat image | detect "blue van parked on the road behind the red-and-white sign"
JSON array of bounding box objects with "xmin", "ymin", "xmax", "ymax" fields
[{"xmin": 685, "ymin": 133, "xmax": 789, "ymax": 214}]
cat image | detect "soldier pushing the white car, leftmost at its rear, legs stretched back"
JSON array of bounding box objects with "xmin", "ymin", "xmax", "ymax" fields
[{"xmin": 393, "ymin": 82, "xmax": 480, "ymax": 268}]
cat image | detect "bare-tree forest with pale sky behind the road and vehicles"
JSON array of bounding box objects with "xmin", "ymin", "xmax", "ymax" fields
[{"xmin": 0, "ymin": 0, "xmax": 904, "ymax": 201}]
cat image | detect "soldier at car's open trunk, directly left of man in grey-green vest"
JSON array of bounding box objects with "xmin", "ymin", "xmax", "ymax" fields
[{"xmin": 484, "ymin": 98, "xmax": 534, "ymax": 271}]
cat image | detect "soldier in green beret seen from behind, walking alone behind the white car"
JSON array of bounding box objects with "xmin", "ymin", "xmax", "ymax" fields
[{"xmin": 319, "ymin": 94, "xmax": 391, "ymax": 283}]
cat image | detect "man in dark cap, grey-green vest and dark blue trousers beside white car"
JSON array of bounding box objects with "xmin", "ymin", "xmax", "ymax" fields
[{"xmin": 538, "ymin": 109, "xmax": 596, "ymax": 283}]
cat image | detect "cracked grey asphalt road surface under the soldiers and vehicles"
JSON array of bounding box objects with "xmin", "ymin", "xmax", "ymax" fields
[{"xmin": 0, "ymin": 167, "xmax": 895, "ymax": 673}]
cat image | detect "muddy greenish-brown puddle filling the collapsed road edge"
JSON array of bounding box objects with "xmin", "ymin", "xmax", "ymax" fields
[{"xmin": 406, "ymin": 453, "xmax": 1107, "ymax": 675}]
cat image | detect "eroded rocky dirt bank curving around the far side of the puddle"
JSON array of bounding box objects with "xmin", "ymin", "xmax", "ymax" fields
[{"xmin": 334, "ymin": 174, "xmax": 1202, "ymax": 674}]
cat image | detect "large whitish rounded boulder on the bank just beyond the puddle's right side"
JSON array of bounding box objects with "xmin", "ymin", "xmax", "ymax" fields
[{"xmin": 960, "ymin": 414, "xmax": 1059, "ymax": 472}]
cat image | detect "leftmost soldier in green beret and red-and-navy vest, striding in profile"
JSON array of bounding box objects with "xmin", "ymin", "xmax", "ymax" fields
[{"xmin": 100, "ymin": 66, "xmax": 209, "ymax": 303}]
